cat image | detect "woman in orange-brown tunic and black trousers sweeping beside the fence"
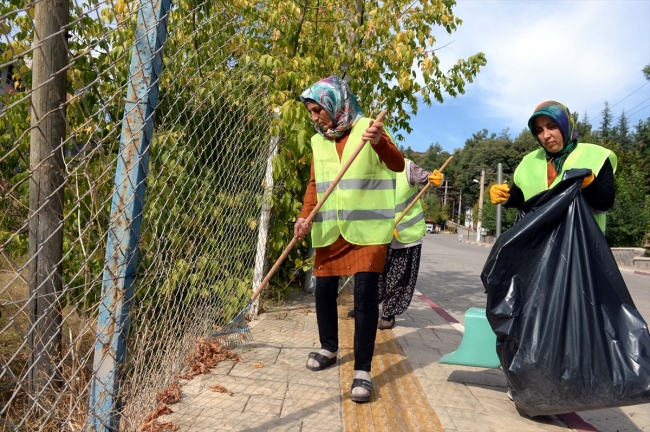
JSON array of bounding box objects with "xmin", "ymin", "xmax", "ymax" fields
[{"xmin": 294, "ymin": 76, "xmax": 404, "ymax": 402}]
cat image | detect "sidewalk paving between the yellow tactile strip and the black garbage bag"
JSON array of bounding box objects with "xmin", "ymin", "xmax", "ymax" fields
[{"xmin": 393, "ymin": 297, "xmax": 571, "ymax": 432}]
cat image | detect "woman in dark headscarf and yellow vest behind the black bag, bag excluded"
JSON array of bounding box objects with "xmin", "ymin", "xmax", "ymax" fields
[{"xmin": 490, "ymin": 101, "xmax": 617, "ymax": 232}]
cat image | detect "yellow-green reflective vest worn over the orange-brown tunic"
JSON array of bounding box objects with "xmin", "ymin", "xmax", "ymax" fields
[{"xmin": 311, "ymin": 118, "xmax": 396, "ymax": 248}]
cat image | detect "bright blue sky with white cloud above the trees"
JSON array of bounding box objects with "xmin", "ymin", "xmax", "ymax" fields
[{"xmin": 400, "ymin": 0, "xmax": 650, "ymax": 151}]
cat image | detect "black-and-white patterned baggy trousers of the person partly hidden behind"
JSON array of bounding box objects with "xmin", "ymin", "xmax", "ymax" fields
[{"xmin": 379, "ymin": 244, "xmax": 422, "ymax": 316}]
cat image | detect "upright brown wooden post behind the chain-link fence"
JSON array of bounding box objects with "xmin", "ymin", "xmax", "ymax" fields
[{"xmin": 27, "ymin": 0, "xmax": 69, "ymax": 404}]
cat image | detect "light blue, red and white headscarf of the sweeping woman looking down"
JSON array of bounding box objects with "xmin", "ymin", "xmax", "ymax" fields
[{"xmin": 300, "ymin": 75, "xmax": 363, "ymax": 139}]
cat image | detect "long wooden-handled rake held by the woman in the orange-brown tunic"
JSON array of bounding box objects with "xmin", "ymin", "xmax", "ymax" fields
[{"xmin": 210, "ymin": 110, "xmax": 386, "ymax": 347}]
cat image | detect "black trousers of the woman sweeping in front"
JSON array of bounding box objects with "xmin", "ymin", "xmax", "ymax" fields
[{"xmin": 314, "ymin": 272, "xmax": 379, "ymax": 372}]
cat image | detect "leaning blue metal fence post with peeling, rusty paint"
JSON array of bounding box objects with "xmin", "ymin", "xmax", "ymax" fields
[{"xmin": 88, "ymin": 0, "xmax": 170, "ymax": 431}]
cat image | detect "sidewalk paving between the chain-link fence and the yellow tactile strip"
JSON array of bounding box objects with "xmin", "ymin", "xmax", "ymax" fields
[{"xmin": 159, "ymin": 295, "xmax": 344, "ymax": 432}]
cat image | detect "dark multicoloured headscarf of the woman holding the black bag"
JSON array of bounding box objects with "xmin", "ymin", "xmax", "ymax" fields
[{"xmin": 528, "ymin": 101, "xmax": 578, "ymax": 173}]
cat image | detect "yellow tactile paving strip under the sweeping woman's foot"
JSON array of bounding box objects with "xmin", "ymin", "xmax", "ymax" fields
[{"xmin": 338, "ymin": 288, "xmax": 443, "ymax": 432}]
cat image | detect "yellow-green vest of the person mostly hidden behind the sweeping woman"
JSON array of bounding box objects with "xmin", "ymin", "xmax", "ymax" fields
[{"xmin": 395, "ymin": 160, "xmax": 427, "ymax": 244}]
